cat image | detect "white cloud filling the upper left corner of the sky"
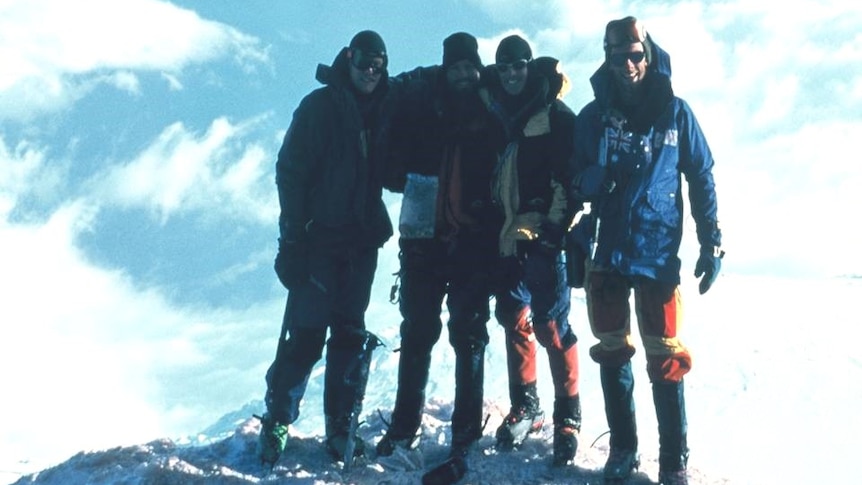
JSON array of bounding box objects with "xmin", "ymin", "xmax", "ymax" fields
[{"xmin": 0, "ymin": 0, "xmax": 268, "ymax": 119}]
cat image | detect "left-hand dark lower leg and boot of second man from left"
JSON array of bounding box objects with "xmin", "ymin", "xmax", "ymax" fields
[{"xmin": 376, "ymin": 347, "xmax": 431, "ymax": 456}]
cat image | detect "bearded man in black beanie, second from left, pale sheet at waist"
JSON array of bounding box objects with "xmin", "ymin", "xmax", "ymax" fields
[{"xmin": 377, "ymin": 32, "xmax": 499, "ymax": 457}]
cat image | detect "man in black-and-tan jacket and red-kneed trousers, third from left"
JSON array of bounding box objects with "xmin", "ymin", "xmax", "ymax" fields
[{"xmin": 486, "ymin": 35, "xmax": 581, "ymax": 466}]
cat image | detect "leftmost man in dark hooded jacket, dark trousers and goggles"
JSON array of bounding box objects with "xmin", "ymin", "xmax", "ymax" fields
[{"xmin": 259, "ymin": 31, "xmax": 404, "ymax": 465}]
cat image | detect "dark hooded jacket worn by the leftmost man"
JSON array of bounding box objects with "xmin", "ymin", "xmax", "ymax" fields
[{"xmin": 276, "ymin": 48, "xmax": 402, "ymax": 250}]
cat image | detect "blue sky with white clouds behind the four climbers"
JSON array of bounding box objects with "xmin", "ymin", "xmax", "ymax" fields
[{"xmin": 0, "ymin": 0, "xmax": 862, "ymax": 480}]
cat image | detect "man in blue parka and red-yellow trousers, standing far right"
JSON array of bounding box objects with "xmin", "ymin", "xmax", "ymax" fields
[{"xmin": 571, "ymin": 17, "xmax": 724, "ymax": 485}]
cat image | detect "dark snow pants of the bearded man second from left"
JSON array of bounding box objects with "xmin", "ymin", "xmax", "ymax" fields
[{"xmin": 389, "ymin": 233, "xmax": 495, "ymax": 441}]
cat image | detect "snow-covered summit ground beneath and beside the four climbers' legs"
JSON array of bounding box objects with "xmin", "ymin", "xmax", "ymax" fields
[{"xmin": 4, "ymin": 275, "xmax": 862, "ymax": 485}]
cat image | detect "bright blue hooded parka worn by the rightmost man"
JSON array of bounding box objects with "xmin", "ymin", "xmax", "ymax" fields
[{"xmin": 571, "ymin": 38, "xmax": 721, "ymax": 284}]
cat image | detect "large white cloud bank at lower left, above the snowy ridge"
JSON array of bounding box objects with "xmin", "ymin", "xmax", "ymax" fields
[{"xmin": 0, "ymin": 201, "xmax": 281, "ymax": 466}]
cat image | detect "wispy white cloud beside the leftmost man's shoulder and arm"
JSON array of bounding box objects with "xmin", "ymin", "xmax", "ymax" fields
[{"xmin": 90, "ymin": 118, "xmax": 278, "ymax": 223}]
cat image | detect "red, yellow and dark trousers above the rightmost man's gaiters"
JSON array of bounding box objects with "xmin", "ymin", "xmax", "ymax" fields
[{"xmin": 584, "ymin": 270, "xmax": 691, "ymax": 382}]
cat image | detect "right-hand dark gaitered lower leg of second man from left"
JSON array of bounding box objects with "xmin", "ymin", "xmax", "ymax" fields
[{"xmin": 450, "ymin": 341, "xmax": 485, "ymax": 457}]
